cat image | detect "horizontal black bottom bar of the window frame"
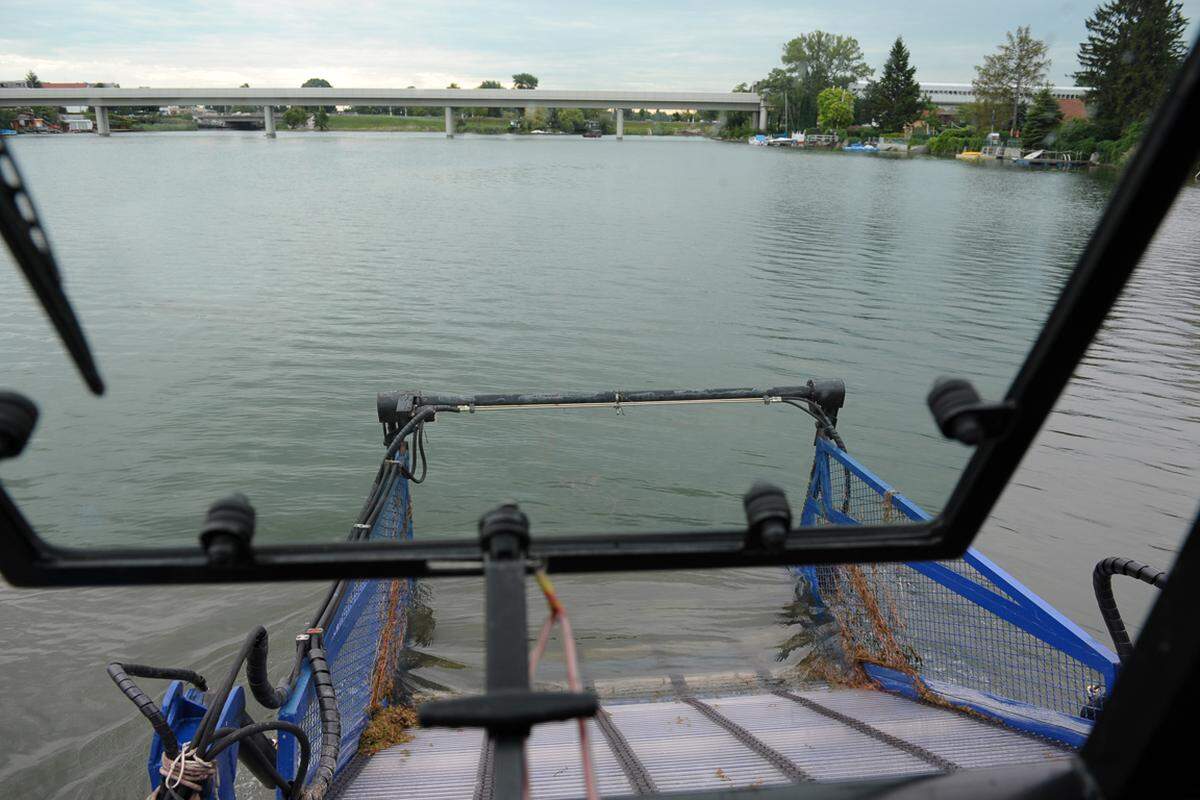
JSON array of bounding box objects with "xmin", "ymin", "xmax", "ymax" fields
[{"xmin": 0, "ymin": 515, "xmax": 941, "ymax": 587}]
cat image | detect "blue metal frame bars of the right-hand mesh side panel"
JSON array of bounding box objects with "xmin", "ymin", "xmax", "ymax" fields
[{"xmin": 797, "ymin": 439, "xmax": 1120, "ymax": 746}]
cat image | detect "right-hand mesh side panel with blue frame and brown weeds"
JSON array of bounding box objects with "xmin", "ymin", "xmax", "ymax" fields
[{"xmin": 800, "ymin": 440, "xmax": 1112, "ymax": 718}]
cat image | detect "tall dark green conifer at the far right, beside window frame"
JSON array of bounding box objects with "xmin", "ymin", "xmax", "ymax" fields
[{"xmin": 1075, "ymin": 0, "xmax": 1188, "ymax": 138}]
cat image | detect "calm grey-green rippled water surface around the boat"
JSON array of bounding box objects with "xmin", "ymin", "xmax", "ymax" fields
[{"xmin": 0, "ymin": 133, "xmax": 1200, "ymax": 798}]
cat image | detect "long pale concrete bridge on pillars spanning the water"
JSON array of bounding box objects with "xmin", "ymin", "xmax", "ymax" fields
[{"xmin": 0, "ymin": 86, "xmax": 767, "ymax": 139}]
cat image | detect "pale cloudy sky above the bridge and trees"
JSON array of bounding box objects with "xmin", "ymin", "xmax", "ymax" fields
[{"xmin": 7, "ymin": 0, "xmax": 1200, "ymax": 91}]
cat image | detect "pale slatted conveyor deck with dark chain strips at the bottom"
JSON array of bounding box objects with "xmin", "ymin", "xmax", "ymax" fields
[{"xmin": 336, "ymin": 685, "xmax": 1070, "ymax": 800}]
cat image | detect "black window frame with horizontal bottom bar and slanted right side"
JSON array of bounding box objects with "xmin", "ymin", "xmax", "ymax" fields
[{"xmin": 0, "ymin": 38, "xmax": 1200, "ymax": 587}]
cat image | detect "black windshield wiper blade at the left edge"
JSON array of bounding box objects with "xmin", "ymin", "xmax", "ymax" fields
[{"xmin": 0, "ymin": 137, "xmax": 104, "ymax": 395}]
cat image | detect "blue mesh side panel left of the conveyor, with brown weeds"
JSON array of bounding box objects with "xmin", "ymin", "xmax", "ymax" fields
[{"xmin": 280, "ymin": 462, "xmax": 415, "ymax": 778}]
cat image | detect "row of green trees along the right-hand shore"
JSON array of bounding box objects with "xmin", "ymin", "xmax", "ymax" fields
[{"xmin": 727, "ymin": 0, "xmax": 1188, "ymax": 160}]
